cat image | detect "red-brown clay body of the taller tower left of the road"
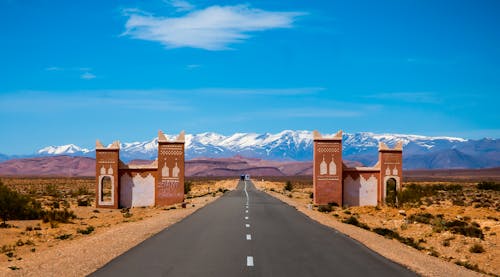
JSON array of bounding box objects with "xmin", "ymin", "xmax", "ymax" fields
[{"xmin": 155, "ymin": 141, "xmax": 184, "ymax": 206}]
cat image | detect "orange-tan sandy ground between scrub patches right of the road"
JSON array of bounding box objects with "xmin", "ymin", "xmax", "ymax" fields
[{"xmin": 254, "ymin": 181, "xmax": 499, "ymax": 276}]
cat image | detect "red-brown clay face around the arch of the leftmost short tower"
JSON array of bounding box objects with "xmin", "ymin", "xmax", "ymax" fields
[{"xmin": 95, "ymin": 149, "xmax": 120, "ymax": 209}]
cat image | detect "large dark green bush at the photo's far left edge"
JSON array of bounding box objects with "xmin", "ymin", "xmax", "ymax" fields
[{"xmin": 0, "ymin": 182, "xmax": 42, "ymax": 226}]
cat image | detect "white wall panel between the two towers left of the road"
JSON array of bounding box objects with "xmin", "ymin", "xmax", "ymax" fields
[{"xmin": 120, "ymin": 173, "xmax": 155, "ymax": 207}]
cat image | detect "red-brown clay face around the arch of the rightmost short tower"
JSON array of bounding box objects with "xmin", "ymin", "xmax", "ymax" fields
[{"xmin": 378, "ymin": 150, "xmax": 403, "ymax": 204}]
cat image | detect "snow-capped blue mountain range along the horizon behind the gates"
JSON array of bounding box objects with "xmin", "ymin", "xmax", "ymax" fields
[{"xmin": 31, "ymin": 130, "xmax": 500, "ymax": 169}]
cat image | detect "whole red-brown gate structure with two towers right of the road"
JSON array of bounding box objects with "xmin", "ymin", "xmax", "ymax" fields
[{"xmin": 313, "ymin": 131, "xmax": 403, "ymax": 206}]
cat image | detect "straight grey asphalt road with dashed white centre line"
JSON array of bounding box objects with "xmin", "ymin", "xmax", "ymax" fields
[{"xmin": 91, "ymin": 181, "xmax": 416, "ymax": 277}]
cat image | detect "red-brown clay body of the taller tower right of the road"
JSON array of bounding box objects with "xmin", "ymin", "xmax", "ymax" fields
[{"xmin": 313, "ymin": 139, "xmax": 342, "ymax": 206}]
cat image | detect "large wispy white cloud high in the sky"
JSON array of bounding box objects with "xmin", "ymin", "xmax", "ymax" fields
[{"xmin": 124, "ymin": 5, "xmax": 304, "ymax": 51}]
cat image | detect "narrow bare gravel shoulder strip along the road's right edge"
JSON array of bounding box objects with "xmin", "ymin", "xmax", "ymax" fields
[{"xmin": 262, "ymin": 189, "xmax": 485, "ymax": 276}]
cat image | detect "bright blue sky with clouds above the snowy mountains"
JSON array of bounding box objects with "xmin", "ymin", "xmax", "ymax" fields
[{"xmin": 0, "ymin": 0, "xmax": 500, "ymax": 154}]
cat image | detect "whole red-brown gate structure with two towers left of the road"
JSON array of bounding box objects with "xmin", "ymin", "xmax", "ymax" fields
[{"xmin": 96, "ymin": 131, "xmax": 184, "ymax": 209}]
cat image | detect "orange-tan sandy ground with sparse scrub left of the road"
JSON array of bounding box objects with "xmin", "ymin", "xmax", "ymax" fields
[{"xmin": 0, "ymin": 180, "xmax": 237, "ymax": 276}]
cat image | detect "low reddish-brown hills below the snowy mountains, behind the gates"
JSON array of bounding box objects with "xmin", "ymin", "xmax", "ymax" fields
[{"xmin": 0, "ymin": 156, "xmax": 500, "ymax": 182}]
